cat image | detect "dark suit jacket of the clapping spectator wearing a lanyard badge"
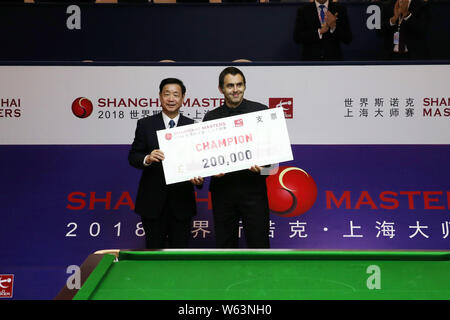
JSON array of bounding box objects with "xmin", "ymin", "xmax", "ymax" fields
[{"xmin": 380, "ymin": 0, "xmax": 430, "ymax": 59}]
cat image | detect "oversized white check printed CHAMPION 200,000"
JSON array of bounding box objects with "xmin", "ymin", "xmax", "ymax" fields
[{"xmin": 157, "ymin": 108, "xmax": 293, "ymax": 184}]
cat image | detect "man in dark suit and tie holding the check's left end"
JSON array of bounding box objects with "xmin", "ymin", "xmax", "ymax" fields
[{"xmin": 128, "ymin": 78, "xmax": 203, "ymax": 249}]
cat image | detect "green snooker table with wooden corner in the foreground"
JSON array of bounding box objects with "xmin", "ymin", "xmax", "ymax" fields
[{"xmin": 55, "ymin": 249, "xmax": 450, "ymax": 300}]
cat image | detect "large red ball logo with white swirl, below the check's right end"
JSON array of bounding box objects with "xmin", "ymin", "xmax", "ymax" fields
[{"xmin": 266, "ymin": 166, "xmax": 317, "ymax": 217}]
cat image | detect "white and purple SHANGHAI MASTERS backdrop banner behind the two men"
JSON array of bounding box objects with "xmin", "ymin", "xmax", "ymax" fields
[{"xmin": 0, "ymin": 65, "xmax": 450, "ymax": 299}]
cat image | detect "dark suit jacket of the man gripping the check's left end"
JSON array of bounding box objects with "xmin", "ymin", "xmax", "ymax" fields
[{"xmin": 128, "ymin": 113, "xmax": 196, "ymax": 219}]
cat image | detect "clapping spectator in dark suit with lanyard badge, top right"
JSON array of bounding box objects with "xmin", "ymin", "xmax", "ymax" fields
[{"xmin": 380, "ymin": 0, "xmax": 430, "ymax": 60}]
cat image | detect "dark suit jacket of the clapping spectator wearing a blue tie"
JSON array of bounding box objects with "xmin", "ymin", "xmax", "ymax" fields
[{"xmin": 294, "ymin": 0, "xmax": 352, "ymax": 60}]
